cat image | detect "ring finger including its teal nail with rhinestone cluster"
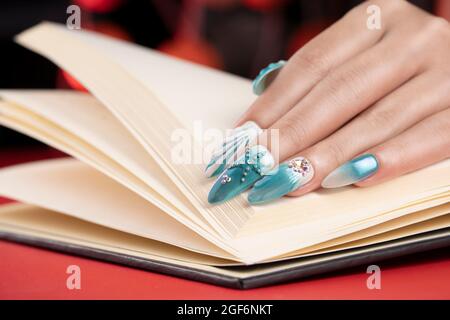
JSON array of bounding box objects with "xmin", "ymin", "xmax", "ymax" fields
[{"xmin": 249, "ymin": 72, "xmax": 450, "ymax": 203}]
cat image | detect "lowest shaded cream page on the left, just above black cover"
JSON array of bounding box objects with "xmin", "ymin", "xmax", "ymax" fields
[{"xmin": 0, "ymin": 203, "xmax": 239, "ymax": 266}]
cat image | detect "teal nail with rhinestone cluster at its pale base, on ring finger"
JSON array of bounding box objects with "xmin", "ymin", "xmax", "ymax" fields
[{"xmin": 248, "ymin": 157, "xmax": 314, "ymax": 204}]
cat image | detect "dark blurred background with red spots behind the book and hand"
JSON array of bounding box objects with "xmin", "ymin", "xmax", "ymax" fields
[{"xmin": 0, "ymin": 0, "xmax": 450, "ymax": 166}]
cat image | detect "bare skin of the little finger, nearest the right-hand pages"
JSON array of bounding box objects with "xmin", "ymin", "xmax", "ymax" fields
[{"xmin": 356, "ymin": 108, "xmax": 450, "ymax": 187}]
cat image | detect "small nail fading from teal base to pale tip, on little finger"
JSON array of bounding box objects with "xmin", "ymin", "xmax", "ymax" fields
[{"xmin": 322, "ymin": 154, "xmax": 379, "ymax": 188}]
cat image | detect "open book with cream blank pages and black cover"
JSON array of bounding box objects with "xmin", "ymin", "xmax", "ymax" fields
[{"xmin": 0, "ymin": 23, "xmax": 450, "ymax": 288}]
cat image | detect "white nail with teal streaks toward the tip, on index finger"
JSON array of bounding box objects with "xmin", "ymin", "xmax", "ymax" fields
[{"xmin": 205, "ymin": 121, "xmax": 262, "ymax": 177}]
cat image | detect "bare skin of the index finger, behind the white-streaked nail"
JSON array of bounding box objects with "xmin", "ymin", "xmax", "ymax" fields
[{"xmin": 236, "ymin": 4, "xmax": 385, "ymax": 128}]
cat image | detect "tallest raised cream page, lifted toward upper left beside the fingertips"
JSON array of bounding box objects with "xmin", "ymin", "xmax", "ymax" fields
[{"xmin": 16, "ymin": 23, "xmax": 254, "ymax": 238}]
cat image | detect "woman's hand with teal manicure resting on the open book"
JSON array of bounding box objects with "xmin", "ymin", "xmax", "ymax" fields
[{"xmin": 207, "ymin": 0, "xmax": 450, "ymax": 203}]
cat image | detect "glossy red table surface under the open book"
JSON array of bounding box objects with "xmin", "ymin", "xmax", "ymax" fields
[{"xmin": 0, "ymin": 149, "xmax": 450, "ymax": 299}]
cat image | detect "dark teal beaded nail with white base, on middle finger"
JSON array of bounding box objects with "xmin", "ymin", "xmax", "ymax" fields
[{"xmin": 208, "ymin": 145, "xmax": 275, "ymax": 203}]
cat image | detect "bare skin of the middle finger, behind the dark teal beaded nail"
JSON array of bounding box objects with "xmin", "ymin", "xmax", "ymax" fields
[{"xmin": 271, "ymin": 31, "xmax": 421, "ymax": 160}]
